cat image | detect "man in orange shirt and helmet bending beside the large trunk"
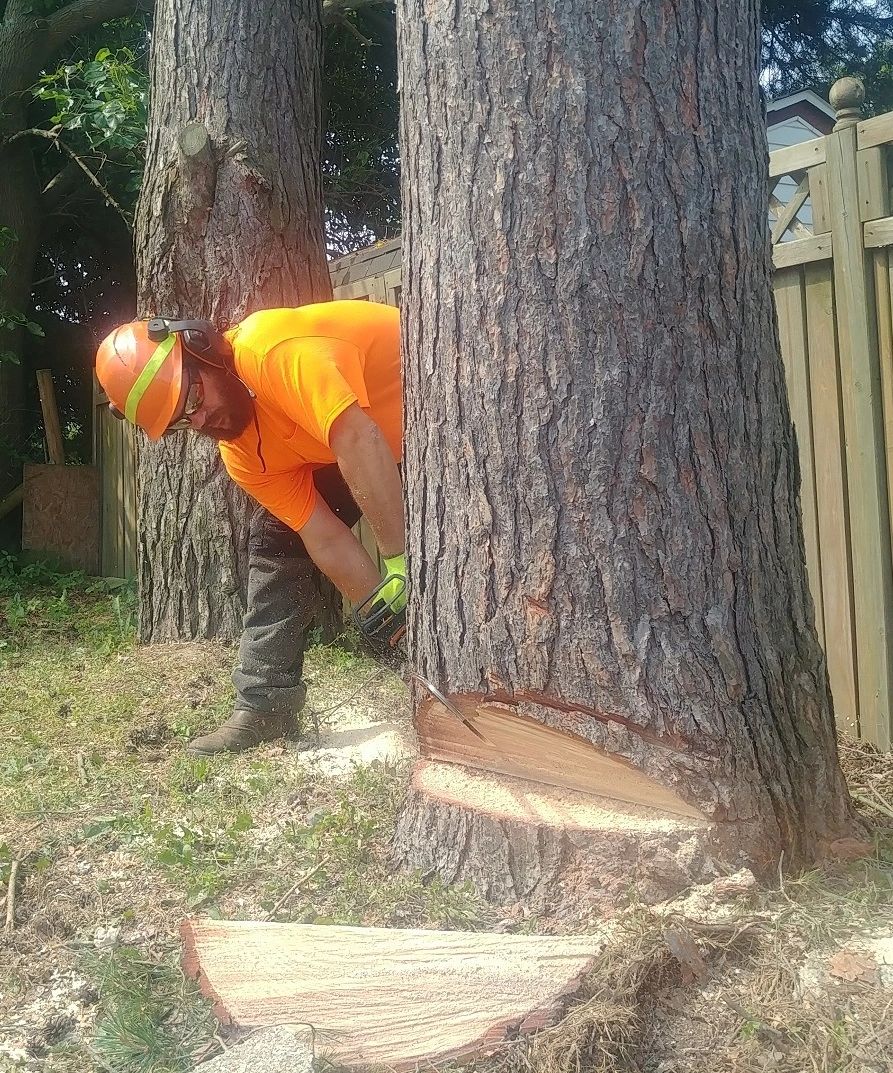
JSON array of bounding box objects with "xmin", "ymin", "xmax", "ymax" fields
[{"xmin": 97, "ymin": 302, "xmax": 406, "ymax": 755}]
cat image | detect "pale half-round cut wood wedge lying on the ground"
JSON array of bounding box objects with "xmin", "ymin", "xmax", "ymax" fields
[{"xmin": 182, "ymin": 921, "xmax": 603, "ymax": 1071}]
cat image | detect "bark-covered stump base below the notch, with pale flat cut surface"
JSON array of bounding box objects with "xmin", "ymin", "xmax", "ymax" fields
[{"xmin": 394, "ymin": 761, "xmax": 717, "ymax": 910}]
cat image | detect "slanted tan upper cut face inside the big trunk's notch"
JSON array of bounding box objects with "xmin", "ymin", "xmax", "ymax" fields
[{"xmin": 415, "ymin": 697, "xmax": 705, "ymax": 819}]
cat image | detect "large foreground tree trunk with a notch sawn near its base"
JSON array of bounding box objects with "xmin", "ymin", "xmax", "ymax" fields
[{"xmin": 397, "ymin": 0, "xmax": 851, "ymax": 897}]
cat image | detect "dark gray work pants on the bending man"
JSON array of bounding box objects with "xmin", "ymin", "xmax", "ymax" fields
[{"xmin": 233, "ymin": 466, "xmax": 361, "ymax": 715}]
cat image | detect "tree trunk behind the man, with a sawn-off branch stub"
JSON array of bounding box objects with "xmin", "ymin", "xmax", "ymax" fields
[{"xmin": 136, "ymin": 0, "xmax": 332, "ymax": 641}]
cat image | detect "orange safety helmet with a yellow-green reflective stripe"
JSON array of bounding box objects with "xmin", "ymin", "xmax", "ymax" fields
[{"xmin": 97, "ymin": 321, "xmax": 184, "ymax": 440}]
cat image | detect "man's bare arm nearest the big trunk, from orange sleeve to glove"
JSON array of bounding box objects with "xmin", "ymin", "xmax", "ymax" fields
[{"xmin": 328, "ymin": 403, "xmax": 406, "ymax": 559}]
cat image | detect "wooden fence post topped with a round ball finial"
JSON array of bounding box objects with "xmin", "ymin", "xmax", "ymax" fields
[{"xmin": 828, "ymin": 78, "xmax": 893, "ymax": 748}]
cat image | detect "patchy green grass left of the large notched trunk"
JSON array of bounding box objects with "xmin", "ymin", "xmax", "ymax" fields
[{"xmin": 0, "ymin": 557, "xmax": 492, "ymax": 1073}]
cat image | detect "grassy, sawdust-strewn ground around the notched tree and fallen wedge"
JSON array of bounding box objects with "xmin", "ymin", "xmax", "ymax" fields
[{"xmin": 0, "ymin": 574, "xmax": 893, "ymax": 1073}]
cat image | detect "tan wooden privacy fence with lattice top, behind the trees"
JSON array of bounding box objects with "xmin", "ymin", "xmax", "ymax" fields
[{"xmin": 94, "ymin": 79, "xmax": 893, "ymax": 749}]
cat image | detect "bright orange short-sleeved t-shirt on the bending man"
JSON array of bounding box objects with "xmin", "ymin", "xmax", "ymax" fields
[{"xmin": 219, "ymin": 302, "xmax": 402, "ymax": 529}]
